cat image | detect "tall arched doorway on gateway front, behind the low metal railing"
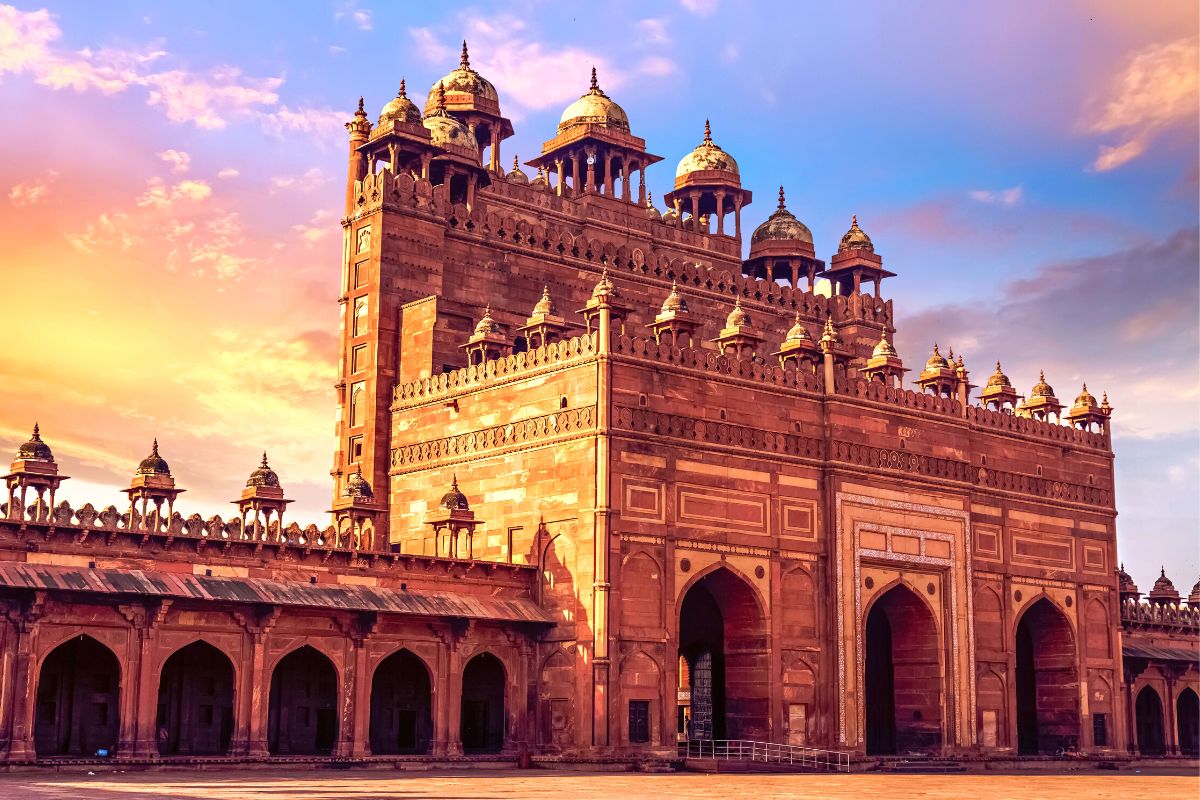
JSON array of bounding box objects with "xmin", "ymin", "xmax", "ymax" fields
[{"xmin": 679, "ymin": 567, "xmax": 770, "ymax": 741}]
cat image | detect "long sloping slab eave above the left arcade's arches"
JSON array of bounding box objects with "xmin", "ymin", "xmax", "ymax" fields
[{"xmin": 0, "ymin": 561, "xmax": 553, "ymax": 624}]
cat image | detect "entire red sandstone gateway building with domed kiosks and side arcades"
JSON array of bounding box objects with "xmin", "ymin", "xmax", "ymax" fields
[{"xmin": 0, "ymin": 46, "xmax": 1200, "ymax": 764}]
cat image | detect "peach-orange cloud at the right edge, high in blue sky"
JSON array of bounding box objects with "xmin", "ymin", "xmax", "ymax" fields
[{"xmin": 1085, "ymin": 37, "xmax": 1200, "ymax": 172}]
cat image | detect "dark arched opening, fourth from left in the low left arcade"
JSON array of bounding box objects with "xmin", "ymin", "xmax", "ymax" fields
[{"xmin": 371, "ymin": 650, "xmax": 433, "ymax": 756}]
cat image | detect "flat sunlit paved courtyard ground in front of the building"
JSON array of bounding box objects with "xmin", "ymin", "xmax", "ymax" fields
[{"xmin": 0, "ymin": 770, "xmax": 1200, "ymax": 800}]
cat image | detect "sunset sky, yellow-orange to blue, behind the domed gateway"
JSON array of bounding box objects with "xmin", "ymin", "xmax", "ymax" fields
[{"xmin": 0, "ymin": 0, "xmax": 1200, "ymax": 594}]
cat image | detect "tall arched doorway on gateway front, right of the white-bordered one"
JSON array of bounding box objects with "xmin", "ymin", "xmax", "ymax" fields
[{"xmin": 1014, "ymin": 597, "xmax": 1079, "ymax": 756}]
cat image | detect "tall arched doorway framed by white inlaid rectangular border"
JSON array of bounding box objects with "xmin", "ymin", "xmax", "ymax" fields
[{"xmin": 863, "ymin": 585, "xmax": 942, "ymax": 754}]
